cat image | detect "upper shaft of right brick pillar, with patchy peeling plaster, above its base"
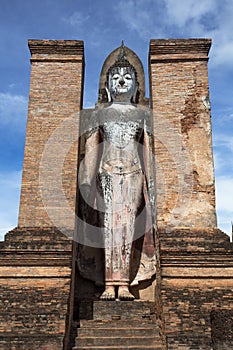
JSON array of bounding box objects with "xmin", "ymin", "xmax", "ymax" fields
[{"xmin": 149, "ymin": 39, "xmax": 216, "ymax": 228}]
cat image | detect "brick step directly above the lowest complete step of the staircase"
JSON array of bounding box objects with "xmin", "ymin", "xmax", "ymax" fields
[{"xmin": 78, "ymin": 326, "xmax": 159, "ymax": 338}]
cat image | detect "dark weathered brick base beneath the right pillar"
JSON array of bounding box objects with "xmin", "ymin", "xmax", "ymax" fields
[{"xmin": 159, "ymin": 229, "xmax": 233, "ymax": 350}]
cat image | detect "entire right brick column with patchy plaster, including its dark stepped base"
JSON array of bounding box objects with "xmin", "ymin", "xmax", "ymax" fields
[{"xmin": 149, "ymin": 39, "xmax": 233, "ymax": 350}]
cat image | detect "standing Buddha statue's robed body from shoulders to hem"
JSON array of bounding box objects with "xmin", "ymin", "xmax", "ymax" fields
[{"xmin": 78, "ymin": 103, "xmax": 155, "ymax": 285}]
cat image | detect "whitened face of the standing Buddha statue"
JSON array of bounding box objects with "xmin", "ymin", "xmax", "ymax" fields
[{"xmin": 109, "ymin": 67, "xmax": 136, "ymax": 102}]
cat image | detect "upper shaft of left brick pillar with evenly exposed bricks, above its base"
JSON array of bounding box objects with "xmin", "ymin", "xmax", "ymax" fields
[{"xmin": 18, "ymin": 40, "xmax": 84, "ymax": 230}]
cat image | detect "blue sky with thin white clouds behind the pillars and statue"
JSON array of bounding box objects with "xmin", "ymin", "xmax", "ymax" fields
[{"xmin": 0, "ymin": 0, "xmax": 233, "ymax": 239}]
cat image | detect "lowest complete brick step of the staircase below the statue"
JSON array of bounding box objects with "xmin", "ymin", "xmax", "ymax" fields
[{"xmin": 75, "ymin": 336, "xmax": 157, "ymax": 346}]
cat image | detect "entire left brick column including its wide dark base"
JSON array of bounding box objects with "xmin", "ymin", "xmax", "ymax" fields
[{"xmin": 0, "ymin": 40, "xmax": 84, "ymax": 350}]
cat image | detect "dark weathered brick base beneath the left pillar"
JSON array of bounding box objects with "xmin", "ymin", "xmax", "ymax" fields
[{"xmin": 0, "ymin": 228, "xmax": 74, "ymax": 350}]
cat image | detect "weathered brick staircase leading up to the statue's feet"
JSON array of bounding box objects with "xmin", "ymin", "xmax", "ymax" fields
[{"xmin": 73, "ymin": 301, "xmax": 165, "ymax": 350}]
